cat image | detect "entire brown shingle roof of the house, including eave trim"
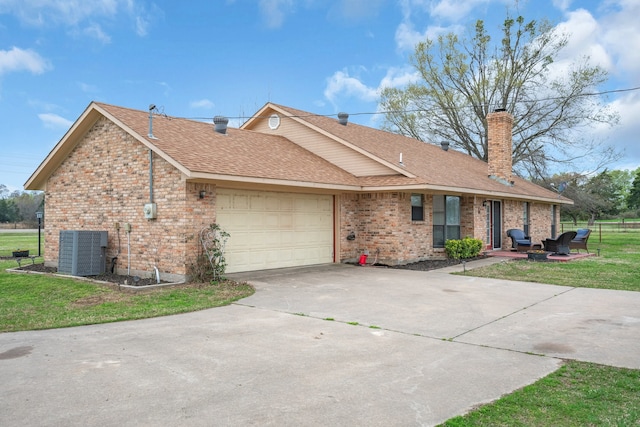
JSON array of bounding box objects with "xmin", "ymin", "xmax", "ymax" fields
[{"xmin": 27, "ymin": 103, "xmax": 571, "ymax": 203}]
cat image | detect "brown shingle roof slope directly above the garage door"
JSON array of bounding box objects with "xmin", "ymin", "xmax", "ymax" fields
[{"xmin": 96, "ymin": 104, "xmax": 358, "ymax": 186}]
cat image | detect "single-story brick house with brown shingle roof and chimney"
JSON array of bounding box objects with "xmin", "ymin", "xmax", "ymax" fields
[{"xmin": 25, "ymin": 102, "xmax": 572, "ymax": 280}]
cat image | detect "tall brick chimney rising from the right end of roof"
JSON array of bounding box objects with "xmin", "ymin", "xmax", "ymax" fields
[{"xmin": 487, "ymin": 110, "xmax": 513, "ymax": 185}]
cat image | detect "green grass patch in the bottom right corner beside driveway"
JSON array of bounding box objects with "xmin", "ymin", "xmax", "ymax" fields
[{"xmin": 443, "ymin": 361, "xmax": 640, "ymax": 427}]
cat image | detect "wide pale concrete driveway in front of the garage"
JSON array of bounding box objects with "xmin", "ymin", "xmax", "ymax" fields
[{"xmin": 0, "ymin": 265, "xmax": 640, "ymax": 426}]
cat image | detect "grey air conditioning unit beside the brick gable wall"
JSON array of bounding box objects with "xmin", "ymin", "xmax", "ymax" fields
[{"xmin": 58, "ymin": 230, "xmax": 108, "ymax": 276}]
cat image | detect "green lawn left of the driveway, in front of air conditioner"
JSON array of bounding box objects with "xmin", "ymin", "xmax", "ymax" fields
[{"xmin": 0, "ymin": 232, "xmax": 254, "ymax": 332}]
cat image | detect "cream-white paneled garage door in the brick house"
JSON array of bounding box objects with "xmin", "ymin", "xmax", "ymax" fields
[{"xmin": 216, "ymin": 189, "xmax": 333, "ymax": 273}]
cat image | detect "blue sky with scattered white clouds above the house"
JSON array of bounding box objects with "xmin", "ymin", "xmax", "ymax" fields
[{"xmin": 0, "ymin": 0, "xmax": 640, "ymax": 191}]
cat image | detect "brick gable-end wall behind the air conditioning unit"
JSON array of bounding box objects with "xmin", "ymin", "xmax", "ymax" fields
[{"xmin": 45, "ymin": 118, "xmax": 215, "ymax": 280}]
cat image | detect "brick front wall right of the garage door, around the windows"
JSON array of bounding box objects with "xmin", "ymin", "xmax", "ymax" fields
[{"xmin": 339, "ymin": 193, "xmax": 551, "ymax": 265}]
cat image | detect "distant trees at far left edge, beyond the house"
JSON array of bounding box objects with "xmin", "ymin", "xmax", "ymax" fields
[{"xmin": 0, "ymin": 184, "xmax": 44, "ymax": 229}]
